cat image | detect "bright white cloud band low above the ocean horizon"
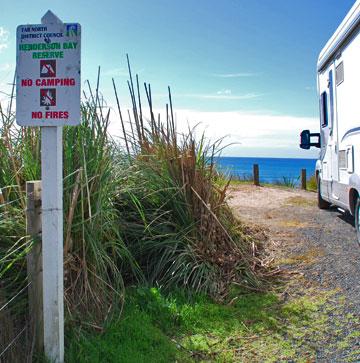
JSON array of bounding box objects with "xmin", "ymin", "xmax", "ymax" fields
[{"xmin": 106, "ymin": 104, "xmax": 319, "ymax": 158}]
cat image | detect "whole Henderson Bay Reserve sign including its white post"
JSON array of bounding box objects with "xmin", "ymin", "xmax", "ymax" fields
[{"xmin": 16, "ymin": 11, "xmax": 81, "ymax": 363}]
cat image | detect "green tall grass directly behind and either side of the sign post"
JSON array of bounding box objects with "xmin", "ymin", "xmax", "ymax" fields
[{"xmin": 0, "ymin": 80, "xmax": 141, "ymax": 361}]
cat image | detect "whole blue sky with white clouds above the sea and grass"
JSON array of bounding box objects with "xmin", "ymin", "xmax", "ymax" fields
[{"xmin": 0, "ymin": 0, "xmax": 355, "ymax": 158}]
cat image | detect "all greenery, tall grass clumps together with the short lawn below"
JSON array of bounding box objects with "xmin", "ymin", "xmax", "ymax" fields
[{"xmin": 0, "ymin": 58, "xmax": 326, "ymax": 362}]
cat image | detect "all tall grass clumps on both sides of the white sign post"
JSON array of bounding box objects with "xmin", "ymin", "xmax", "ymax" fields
[{"xmin": 0, "ymin": 59, "xmax": 263, "ymax": 358}]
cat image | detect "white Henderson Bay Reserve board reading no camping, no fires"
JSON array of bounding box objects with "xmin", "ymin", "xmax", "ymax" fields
[{"xmin": 16, "ymin": 22, "xmax": 81, "ymax": 126}]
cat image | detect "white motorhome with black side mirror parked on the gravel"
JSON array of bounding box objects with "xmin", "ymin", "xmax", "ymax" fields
[{"xmin": 300, "ymin": 0, "xmax": 360, "ymax": 242}]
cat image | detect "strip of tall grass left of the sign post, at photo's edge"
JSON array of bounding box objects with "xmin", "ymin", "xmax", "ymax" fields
[{"xmin": 0, "ymin": 87, "xmax": 36, "ymax": 361}]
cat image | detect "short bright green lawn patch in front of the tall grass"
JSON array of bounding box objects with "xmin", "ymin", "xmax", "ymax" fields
[{"xmin": 67, "ymin": 284, "xmax": 360, "ymax": 363}]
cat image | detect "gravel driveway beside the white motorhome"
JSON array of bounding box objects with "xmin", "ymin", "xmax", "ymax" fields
[{"xmin": 229, "ymin": 185, "xmax": 360, "ymax": 362}]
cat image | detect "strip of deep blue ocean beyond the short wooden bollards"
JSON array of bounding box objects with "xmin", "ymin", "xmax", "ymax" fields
[{"xmin": 216, "ymin": 157, "xmax": 316, "ymax": 184}]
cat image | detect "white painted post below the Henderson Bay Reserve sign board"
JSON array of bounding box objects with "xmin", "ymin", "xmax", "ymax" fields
[{"xmin": 41, "ymin": 126, "xmax": 64, "ymax": 363}]
